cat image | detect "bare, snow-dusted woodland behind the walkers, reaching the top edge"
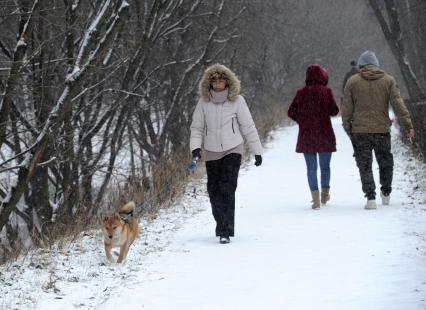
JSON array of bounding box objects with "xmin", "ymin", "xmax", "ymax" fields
[{"xmin": 0, "ymin": 0, "xmax": 426, "ymax": 262}]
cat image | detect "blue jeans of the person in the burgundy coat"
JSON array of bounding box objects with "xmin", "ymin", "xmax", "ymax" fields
[{"xmin": 303, "ymin": 152, "xmax": 331, "ymax": 191}]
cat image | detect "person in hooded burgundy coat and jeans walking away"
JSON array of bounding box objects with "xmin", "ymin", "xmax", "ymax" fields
[{"xmin": 288, "ymin": 64, "xmax": 339, "ymax": 209}]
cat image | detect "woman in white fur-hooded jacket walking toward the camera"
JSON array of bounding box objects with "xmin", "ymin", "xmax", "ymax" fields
[{"xmin": 190, "ymin": 64, "xmax": 263, "ymax": 243}]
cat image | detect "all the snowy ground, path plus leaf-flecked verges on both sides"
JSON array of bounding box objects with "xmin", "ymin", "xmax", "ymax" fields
[{"xmin": 0, "ymin": 119, "xmax": 426, "ymax": 310}]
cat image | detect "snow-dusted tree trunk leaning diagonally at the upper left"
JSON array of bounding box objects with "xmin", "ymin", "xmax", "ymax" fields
[{"xmin": 0, "ymin": 1, "xmax": 128, "ymax": 240}]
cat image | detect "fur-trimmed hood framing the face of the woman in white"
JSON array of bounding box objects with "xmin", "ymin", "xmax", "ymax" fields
[{"xmin": 198, "ymin": 64, "xmax": 240, "ymax": 101}]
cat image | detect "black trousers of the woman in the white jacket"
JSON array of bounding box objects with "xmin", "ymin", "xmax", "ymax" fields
[{"xmin": 206, "ymin": 153, "xmax": 241, "ymax": 237}]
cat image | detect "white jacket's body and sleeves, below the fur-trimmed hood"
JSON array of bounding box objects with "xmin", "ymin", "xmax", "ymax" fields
[{"xmin": 190, "ymin": 95, "xmax": 263, "ymax": 155}]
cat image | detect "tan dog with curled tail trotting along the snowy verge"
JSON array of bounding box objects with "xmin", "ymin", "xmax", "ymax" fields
[{"xmin": 102, "ymin": 201, "xmax": 139, "ymax": 263}]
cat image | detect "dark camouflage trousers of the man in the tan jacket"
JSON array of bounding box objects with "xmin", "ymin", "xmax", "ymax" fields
[{"xmin": 351, "ymin": 133, "xmax": 393, "ymax": 199}]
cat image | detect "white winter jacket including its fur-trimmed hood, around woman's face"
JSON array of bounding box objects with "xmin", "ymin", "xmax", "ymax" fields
[{"xmin": 190, "ymin": 64, "xmax": 263, "ymax": 155}]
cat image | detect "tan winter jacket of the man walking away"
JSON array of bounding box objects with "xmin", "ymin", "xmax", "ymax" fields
[{"xmin": 341, "ymin": 65, "xmax": 413, "ymax": 134}]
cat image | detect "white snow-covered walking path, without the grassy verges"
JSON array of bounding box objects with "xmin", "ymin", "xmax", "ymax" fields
[{"xmin": 101, "ymin": 120, "xmax": 426, "ymax": 310}]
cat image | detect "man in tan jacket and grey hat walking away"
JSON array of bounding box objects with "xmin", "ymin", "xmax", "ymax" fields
[{"xmin": 341, "ymin": 51, "xmax": 414, "ymax": 209}]
